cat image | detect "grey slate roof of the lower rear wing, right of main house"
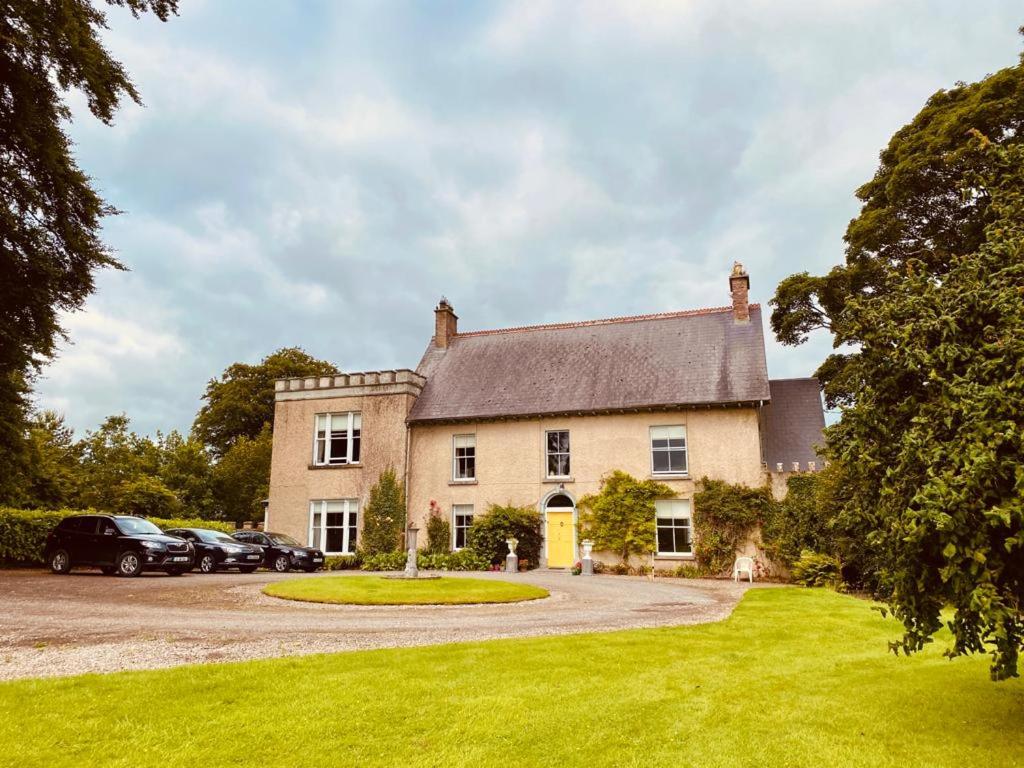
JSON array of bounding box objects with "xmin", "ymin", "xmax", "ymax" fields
[{"xmin": 761, "ymin": 378, "xmax": 825, "ymax": 472}]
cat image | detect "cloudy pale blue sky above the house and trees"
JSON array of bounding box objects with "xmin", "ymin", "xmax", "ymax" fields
[{"xmin": 37, "ymin": 0, "xmax": 1024, "ymax": 434}]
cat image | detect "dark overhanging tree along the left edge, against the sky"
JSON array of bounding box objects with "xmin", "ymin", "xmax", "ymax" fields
[{"xmin": 0, "ymin": 0, "xmax": 177, "ymax": 505}]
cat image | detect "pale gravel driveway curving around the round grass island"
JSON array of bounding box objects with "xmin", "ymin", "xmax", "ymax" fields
[{"xmin": 0, "ymin": 570, "xmax": 765, "ymax": 680}]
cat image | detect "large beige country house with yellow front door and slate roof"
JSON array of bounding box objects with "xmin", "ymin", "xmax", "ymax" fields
[{"xmin": 265, "ymin": 264, "xmax": 824, "ymax": 567}]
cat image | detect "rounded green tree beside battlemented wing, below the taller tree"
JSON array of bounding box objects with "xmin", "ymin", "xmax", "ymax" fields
[{"xmin": 212, "ymin": 424, "xmax": 273, "ymax": 522}]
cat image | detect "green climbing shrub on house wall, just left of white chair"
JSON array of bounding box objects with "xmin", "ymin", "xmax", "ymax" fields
[{"xmin": 693, "ymin": 477, "xmax": 774, "ymax": 574}]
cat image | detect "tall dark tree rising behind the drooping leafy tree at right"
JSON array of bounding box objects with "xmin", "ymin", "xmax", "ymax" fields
[{"xmin": 771, "ymin": 43, "xmax": 1024, "ymax": 408}]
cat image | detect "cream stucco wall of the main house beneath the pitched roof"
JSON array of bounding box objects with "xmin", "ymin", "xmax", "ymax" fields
[{"xmin": 409, "ymin": 408, "xmax": 765, "ymax": 565}]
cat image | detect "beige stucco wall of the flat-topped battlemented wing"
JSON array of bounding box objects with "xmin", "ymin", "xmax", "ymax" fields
[{"xmin": 267, "ymin": 394, "xmax": 413, "ymax": 543}]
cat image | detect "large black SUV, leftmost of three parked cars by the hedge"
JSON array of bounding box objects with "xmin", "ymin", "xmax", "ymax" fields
[{"xmin": 46, "ymin": 515, "xmax": 195, "ymax": 577}]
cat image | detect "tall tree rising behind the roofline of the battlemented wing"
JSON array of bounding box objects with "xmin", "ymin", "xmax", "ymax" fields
[{"xmin": 193, "ymin": 347, "xmax": 337, "ymax": 459}]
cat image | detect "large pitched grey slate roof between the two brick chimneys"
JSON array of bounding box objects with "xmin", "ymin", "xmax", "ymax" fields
[{"xmin": 409, "ymin": 304, "xmax": 769, "ymax": 423}]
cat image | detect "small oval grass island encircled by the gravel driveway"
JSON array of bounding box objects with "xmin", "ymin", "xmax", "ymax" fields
[{"xmin": 263, "ymin": 575, "xmax": 549, "ymax": 605}]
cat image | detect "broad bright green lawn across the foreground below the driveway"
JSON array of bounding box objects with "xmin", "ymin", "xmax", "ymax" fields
[{"xmin": 0, "ymin": 589, "xmax": 1024, "ymax": 768}]
